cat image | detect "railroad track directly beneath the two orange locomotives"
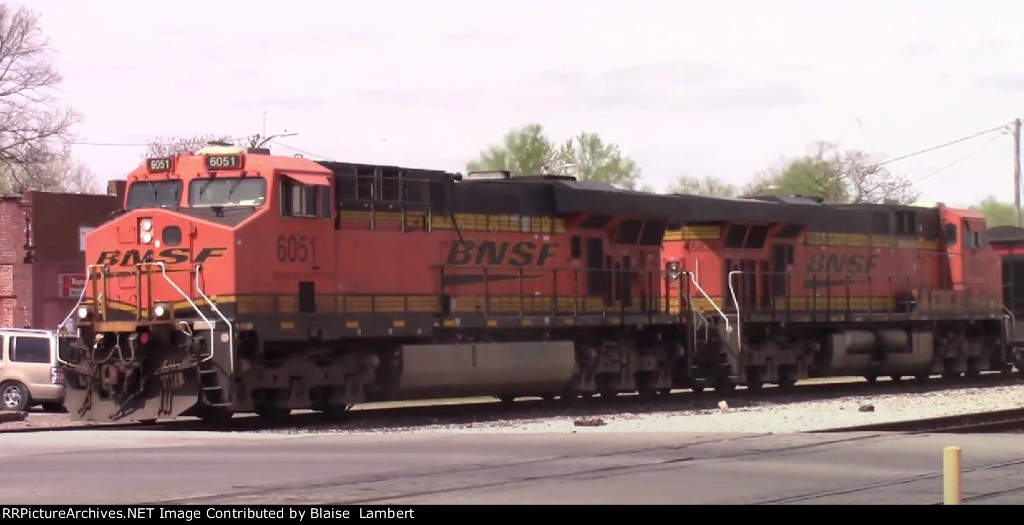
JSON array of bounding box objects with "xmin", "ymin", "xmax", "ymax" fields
[{"xmin": 0, "ymin": 374, "xmax": 1024, "ymax": 435}]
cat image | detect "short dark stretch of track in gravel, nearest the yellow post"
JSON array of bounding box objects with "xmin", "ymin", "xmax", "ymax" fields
[{"xmin": 811, "ymin": 408, "xmax": 1024, "ymax": 434}]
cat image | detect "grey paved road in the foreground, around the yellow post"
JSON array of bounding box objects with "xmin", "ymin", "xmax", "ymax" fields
[{"xmin": 0, "ymin": 430, "xmax": 1024, "ymax": 505}]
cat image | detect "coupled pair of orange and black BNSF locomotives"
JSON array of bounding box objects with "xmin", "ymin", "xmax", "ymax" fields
[{"xmin": 58, "ymin": 146, "xmax": 1012, "ymax": 421}]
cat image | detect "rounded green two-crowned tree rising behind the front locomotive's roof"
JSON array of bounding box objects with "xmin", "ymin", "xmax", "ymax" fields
[{"xmin": 466, "ymin": 124, "xmax": 640, "ymax": 189}]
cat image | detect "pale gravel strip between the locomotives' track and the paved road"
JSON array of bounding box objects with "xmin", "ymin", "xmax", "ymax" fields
[{"xmin": 8, "ymin": 382, "xmax": 1024, "ymax": 434}]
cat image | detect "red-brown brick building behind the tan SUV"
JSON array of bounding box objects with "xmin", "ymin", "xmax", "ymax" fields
[{"xmin": 0, "ymin": 181, "xmax": 124, "ymax": 330}]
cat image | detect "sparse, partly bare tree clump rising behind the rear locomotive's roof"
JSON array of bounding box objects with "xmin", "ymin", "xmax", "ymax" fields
[{"xmin": 743, "ymin": 142, "xmax": 920, "ymax": 204}]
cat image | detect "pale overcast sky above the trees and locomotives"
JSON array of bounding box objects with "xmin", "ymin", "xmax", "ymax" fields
[{"xmin": 23, "ymin": 0, "xmax": 1024, "ymax": 204}]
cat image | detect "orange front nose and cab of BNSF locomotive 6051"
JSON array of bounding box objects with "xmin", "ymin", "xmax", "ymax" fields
[{"xmin": 59, "ymin": 146, "xmax": 333, "ymax": 420}]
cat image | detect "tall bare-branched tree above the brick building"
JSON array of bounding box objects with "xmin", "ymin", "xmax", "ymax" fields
[{"xmin": 0, "ymin": 3, "xmax": 79, "ymax": 190}]
